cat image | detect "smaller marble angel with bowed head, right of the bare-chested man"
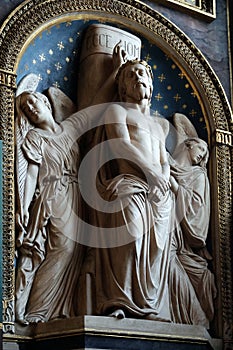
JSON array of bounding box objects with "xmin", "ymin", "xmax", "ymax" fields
[{"xmin": 169, "ymin": 113, "xmax": 216, "ymax": 328}]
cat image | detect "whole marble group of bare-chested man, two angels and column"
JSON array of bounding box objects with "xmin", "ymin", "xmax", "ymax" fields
[{"xmin": 15, "ymin": 24, "xmax": 216, "ymax": 328}]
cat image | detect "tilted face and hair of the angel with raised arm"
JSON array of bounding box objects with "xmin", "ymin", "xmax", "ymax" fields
[{"xmin": 21, "ymin": 94, "xmax": 50, "ymax": 125}]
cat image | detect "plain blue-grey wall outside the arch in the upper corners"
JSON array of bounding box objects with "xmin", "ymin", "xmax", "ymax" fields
[{"xmin": 0, "ymin": 0, "xmax": 229, "ymax": 102}]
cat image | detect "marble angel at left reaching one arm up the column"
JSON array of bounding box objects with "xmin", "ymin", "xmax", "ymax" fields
[{"xmin": 15, "ymin": 45, "xmax": 126, "ymax": 324}]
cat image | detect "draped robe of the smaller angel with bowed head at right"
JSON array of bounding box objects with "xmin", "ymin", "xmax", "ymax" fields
[{"xmin": 169, "ymin": 160, "xmax": 216, "ymax": 328}]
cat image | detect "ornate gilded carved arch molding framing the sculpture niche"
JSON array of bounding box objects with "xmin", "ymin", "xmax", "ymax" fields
[{"xmin": 0, "ymin": 0, "xmax": 233, "ymax": 339}]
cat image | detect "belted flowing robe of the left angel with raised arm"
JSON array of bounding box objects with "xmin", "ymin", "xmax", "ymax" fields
[{"xmin": 16, "ymin": 113, "xmax": 93, "ymax": 321}]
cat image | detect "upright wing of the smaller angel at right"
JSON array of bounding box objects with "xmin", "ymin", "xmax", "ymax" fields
[{"xmin": 173, "ymin": 113, "xmax": 198, "ymax": 146}]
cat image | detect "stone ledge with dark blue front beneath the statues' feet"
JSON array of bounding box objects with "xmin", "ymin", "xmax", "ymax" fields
[{"xmin": 3, "ymin": 316, "xmax": 222, "ymax": 350}]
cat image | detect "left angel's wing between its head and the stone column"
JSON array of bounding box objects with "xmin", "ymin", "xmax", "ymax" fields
[{"xmin": 47, "ymin": 86, "xmax": 77, "ymax": 123}]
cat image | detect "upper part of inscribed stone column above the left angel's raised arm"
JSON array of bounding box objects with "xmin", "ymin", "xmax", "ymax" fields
[{"xmin": 77, "ymin": 24, "xmax": 141, "ymax": 109}]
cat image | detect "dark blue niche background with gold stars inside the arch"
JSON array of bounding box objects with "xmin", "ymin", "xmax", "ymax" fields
[{"xmin": 17, "ymin": 20, "xmax": 207, "ymax": 139}]
